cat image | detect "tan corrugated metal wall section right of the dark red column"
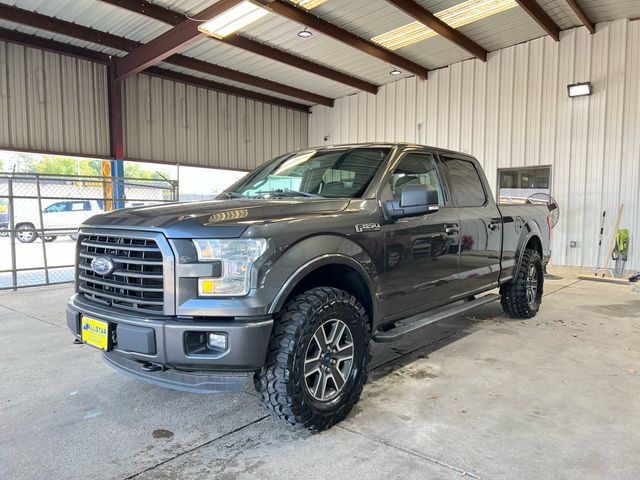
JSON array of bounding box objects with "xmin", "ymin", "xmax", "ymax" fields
[{"xmin": 123, "ymin": 75, "xmax": 309, "ymax": 170}]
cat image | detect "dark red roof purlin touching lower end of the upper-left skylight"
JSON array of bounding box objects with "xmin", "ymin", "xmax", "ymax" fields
[{"xmin": 102, "ymin": 0, "xmax": 378, "ymax": 94}]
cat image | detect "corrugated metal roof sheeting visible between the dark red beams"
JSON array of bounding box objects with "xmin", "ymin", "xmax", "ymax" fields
[{"xmin": 0, "ymin": 0, "xmax": 640, "ymax": 103}]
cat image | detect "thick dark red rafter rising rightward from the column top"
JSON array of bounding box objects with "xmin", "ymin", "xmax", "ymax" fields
[{"xmin": 115, "ymin": 0, "xmax": 242, "ymax": 80}]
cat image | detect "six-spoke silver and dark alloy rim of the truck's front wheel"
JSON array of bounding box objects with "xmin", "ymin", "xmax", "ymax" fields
[{"xmin": 304, "ymin": 318, "xmax": 354, "ymax": 402}]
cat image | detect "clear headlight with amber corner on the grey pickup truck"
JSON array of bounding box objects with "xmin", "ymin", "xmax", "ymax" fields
[{"xmin": 193, "ymin": 238, "xmax": 267, "ymax": 297}]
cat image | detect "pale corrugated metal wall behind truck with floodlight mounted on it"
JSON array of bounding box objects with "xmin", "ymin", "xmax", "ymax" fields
[{"xmin": 309, "ymin": 20, "xmax": 640, "ymax": 269}]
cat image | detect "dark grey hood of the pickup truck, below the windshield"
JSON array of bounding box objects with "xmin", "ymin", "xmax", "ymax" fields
[{"xmin": 81, "ymin": 198, "xmax": 349, "ymax": 238}]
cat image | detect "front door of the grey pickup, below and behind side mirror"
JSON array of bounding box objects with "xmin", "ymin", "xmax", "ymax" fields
[{"xmin": 378, "ymin": 149, "xmax": 459, "ymax": 320}]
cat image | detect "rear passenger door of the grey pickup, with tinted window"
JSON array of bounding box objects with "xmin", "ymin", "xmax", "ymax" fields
[{"xmin": 440, "ymin": 155, "xmax": 502, "ymax": 294}]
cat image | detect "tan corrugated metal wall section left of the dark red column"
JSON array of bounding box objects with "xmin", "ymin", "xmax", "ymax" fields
[{"xmin": 0, "ymin": 41, "xmax": 109, "ymax": 156}]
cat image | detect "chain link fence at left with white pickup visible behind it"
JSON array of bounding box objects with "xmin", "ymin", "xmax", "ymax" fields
[{"xmin": 0, "ymin": 173, "xmax": 178, "ymax": 290}]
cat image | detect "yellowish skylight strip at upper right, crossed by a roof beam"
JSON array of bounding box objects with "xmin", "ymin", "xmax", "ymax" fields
[{"xmin": 371, "ymin": 0, "xmax": 518, "ymax": 50}]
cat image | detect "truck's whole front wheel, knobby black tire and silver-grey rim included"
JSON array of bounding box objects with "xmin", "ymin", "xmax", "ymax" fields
[{"xmin": 254, "ymin": 287, "xmax": 371, "ymax": 431}]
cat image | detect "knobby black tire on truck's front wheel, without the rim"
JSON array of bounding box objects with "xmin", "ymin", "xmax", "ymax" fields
[{"xmin": 254, "ymin": 287, "xmax": 371, "ymax": 431}]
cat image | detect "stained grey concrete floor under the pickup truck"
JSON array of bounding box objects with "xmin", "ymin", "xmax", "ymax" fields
[{"xmin": 0, "ymin": 275, "xmax": 640, "ymax": 480}]
